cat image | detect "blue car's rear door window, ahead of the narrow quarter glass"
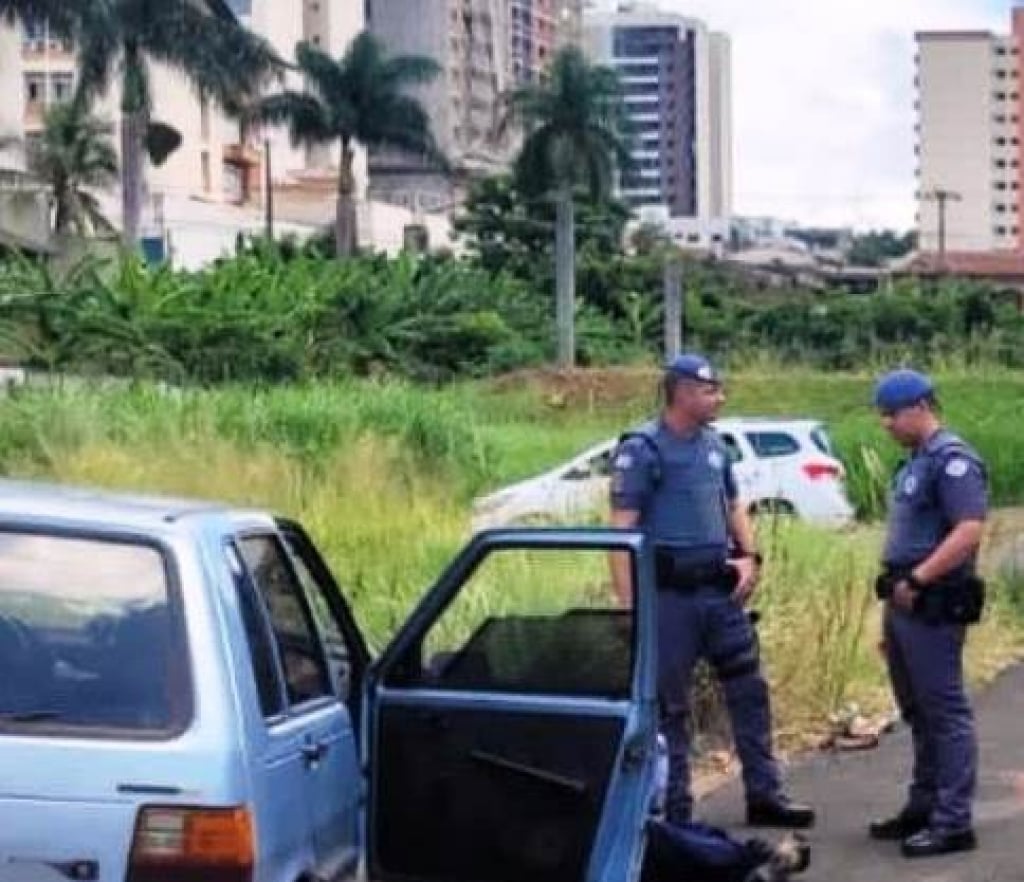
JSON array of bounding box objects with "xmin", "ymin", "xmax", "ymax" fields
[{"xmin": 239, "ymin": 536, "xmax": 331, "ymax": 705}]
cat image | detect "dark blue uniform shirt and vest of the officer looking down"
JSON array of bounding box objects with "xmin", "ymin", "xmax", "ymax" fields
[{"xmin": 884, "ymin": 429, "xmax": 988, "ymax": 569}]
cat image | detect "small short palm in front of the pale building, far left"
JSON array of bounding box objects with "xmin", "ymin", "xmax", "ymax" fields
[{"xmin": 28, "ymin": 103, "xmax": 118, "ymax": 236}]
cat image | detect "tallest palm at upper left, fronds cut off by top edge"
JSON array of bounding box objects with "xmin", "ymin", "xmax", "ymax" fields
[{"xmin": 68, "ymin": 0, "xmax": 281, "ymax": 247}]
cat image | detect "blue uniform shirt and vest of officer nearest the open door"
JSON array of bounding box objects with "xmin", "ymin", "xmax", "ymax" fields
[{"xmin": 611, "ymin": 420, "xmax": 737, "ymax": 557}]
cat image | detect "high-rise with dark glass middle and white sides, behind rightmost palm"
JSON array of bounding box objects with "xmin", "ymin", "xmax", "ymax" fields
[{"xmin": 584, "ymin": 2, "xmax": 732, "ymax": 250}]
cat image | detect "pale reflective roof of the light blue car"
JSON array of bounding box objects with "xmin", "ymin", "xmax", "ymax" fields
[{"xmin": 0, "ymin": 479, "xmax": 264, "ymax": 530}]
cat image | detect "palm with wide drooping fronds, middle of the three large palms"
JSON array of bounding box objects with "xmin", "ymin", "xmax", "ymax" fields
[{"xmin": 257, "ymin": 31, "xmax": 443, "ymax": 256}]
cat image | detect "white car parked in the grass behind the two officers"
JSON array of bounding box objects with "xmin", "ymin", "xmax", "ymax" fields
[{"xmin": 473, "ymin": 417, "xmax": 854, "ymax": 530}]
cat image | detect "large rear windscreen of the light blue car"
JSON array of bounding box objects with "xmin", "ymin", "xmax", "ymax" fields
[{"xmin": 0, "ymin": 532, "xmax": 190, "ymax": 734}]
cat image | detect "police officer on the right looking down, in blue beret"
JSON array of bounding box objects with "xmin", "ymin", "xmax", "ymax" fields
[{"xmin": 869, "ymin": 370, "xmax": 988, "ymax": 857}]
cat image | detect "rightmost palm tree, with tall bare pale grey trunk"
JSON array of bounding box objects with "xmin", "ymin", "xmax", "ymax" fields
[{"xmin": 509, "ymin": 46, "xmax": 630, "ymax": 368}]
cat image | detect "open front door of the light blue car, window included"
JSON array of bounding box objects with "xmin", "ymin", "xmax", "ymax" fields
[{"xmin": 364, "ymin": 529, "xmax": 656, "ymax": 882}]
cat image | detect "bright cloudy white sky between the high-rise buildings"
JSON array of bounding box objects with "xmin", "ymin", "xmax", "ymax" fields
[{"xmin": 654, "ymin": 0, "xmax": 1012, "ymax": 229}]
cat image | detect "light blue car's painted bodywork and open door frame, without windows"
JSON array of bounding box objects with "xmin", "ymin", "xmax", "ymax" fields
[{"xmin": 0, "ymin": 481, "xmax": 655, "ymax": 882}]
